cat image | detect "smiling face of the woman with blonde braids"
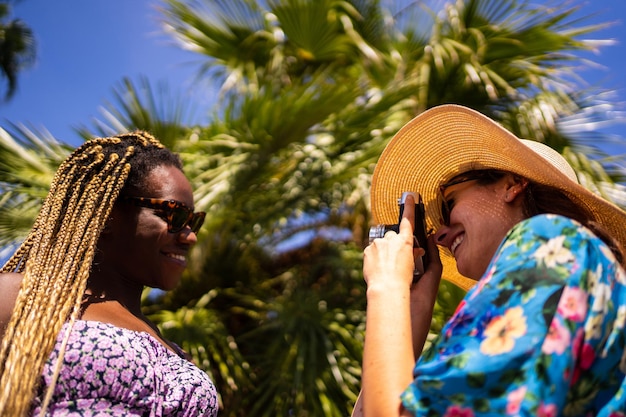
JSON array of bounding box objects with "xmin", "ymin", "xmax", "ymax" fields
[{"xmin": 98, "ymin": 165, "xmax": 196, "ymax": 290}]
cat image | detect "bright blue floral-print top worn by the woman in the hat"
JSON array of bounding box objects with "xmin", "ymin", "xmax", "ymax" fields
[{"xmin": 401, "ymin": 215, "xmax": 626, "ymax": 417}]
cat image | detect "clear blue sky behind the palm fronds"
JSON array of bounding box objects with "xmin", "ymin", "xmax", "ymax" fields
[{"xmin": 0, "ymin": 0, "xmax": 626, "ymax": 152}]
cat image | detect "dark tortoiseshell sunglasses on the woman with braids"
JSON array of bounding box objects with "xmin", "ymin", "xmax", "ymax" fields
[{"xmin": 121, "ymin": 197, "xmax": 206, "ymax": 234}]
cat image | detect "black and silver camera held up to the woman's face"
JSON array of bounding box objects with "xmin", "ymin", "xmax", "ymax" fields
[{"xmin": 369, "ymin": 191, "xmax": 428, "ymax": 283}]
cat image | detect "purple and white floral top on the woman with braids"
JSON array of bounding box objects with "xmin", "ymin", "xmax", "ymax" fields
[{"xmin": 33, "ymin": 320, "xmax": 218, "ymax": 417}]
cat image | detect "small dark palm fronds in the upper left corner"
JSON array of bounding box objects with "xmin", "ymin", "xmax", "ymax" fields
[{"xmin": 0, "ymin": 2, "xmax": 36, "ymax": 100}]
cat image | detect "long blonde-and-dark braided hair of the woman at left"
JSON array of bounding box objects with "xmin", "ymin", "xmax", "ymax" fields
[{"xmin": 0, "ymin": 131, "xmax": 182, "ymax": 417}]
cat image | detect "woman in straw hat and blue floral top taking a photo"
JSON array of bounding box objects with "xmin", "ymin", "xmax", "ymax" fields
[{"xmin": 354, "ymin": 105, "xmax": 626, "ymax": 417}]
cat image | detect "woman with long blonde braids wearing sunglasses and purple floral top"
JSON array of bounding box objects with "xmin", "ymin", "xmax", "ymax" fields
[{"xmin": 0, "ymin": 132, "xmax": 218, "ymax": 417}]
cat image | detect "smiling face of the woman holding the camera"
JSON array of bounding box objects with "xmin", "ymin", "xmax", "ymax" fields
[{"xmin": 435, "ymin": 174, "xmax": 526, "ymax": 280}]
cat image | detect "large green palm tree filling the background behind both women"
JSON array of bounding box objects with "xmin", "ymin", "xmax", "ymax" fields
[{"xmin": 0, "ymin": 0, "xmax": 625, "ymax": 416}]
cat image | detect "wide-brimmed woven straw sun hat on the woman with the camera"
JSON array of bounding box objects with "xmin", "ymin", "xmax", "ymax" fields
[{"xmin": 371, "ymin": 104, "xmax": 626, "ymax": 290}]
